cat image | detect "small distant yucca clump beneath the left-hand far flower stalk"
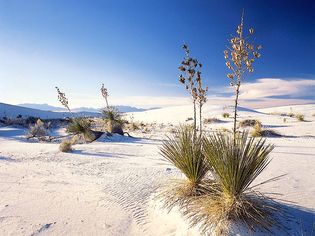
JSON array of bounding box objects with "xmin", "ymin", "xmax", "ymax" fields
[{"xmin": 67, "ymin": 118, "xmax": 95, "ymax": 142}]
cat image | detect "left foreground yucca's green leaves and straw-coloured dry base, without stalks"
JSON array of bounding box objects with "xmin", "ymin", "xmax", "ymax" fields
[{"xmin": 160, "ymin": 126, "xmax": 208, "ymax": 208}]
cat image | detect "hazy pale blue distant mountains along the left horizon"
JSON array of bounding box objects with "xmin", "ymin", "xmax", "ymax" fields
[{"xmin": 18, "ymin": 103, "xmax": 154, "ymax": 113}]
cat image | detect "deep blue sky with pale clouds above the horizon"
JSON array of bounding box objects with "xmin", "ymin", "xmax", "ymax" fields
[{"xmin": 0, "ymin": 0, "xmax": 315, "ymax": 107}]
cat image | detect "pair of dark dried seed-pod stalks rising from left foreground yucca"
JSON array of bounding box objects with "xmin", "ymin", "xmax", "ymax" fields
[{"xmin": 178, "ymin": 44, "xmax": 208, "ymax": 137}]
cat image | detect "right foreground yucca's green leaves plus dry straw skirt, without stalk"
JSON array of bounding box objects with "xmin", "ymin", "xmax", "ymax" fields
[{"xmin": 189, "ymin": 132, "xmax": 277, "ymax": 235}]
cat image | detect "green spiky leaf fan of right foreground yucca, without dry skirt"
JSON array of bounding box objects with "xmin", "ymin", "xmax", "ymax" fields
[{"xmin": 203, "ymin": 132, "xmax": 274, "ymax": 197}]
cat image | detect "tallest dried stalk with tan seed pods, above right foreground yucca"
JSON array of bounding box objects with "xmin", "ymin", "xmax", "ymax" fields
[{"xmin": 224, "ymin": 11, "xmax": 262, "ymax": 139}]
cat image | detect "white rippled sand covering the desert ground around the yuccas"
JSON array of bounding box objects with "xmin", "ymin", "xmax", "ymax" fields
[{"xmin": 0, "ymin": 105, "xmax": 315, "ymax": 236}]
